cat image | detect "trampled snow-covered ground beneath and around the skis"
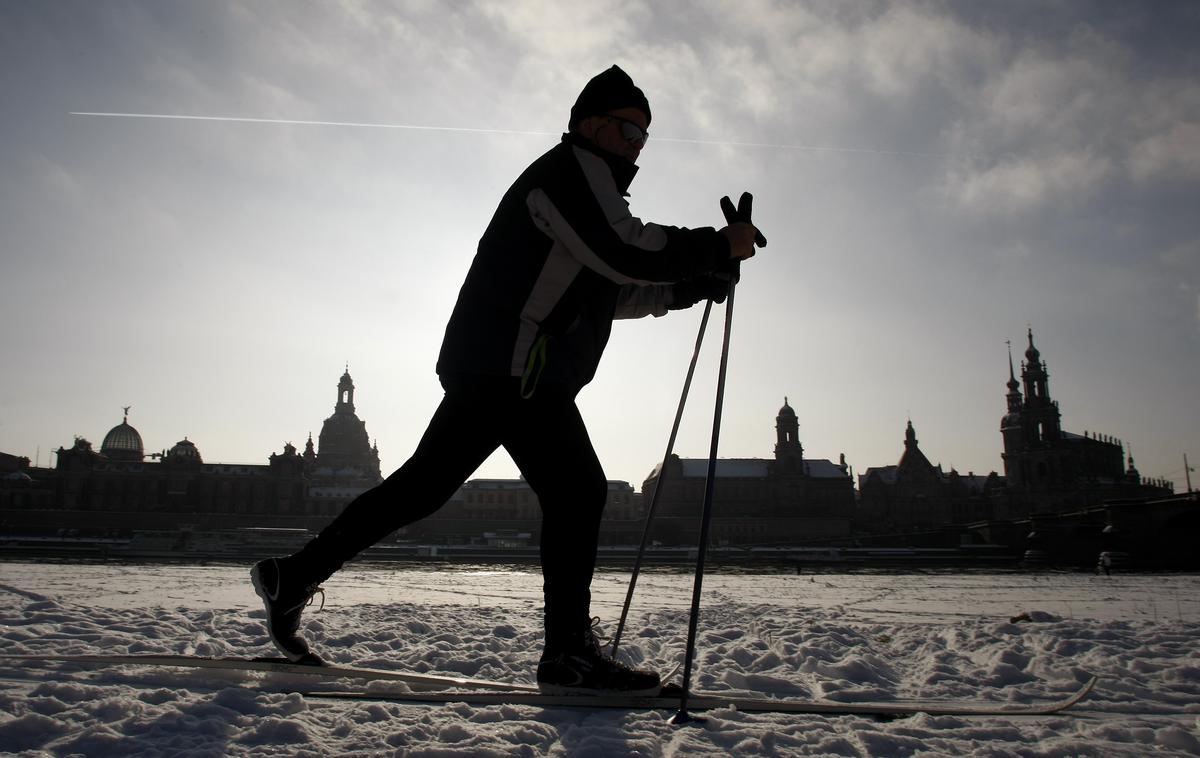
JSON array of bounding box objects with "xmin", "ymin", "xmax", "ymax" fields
[{"xmin": 0, "ymin": 563, "xmax": 1200, "ymax": 757}]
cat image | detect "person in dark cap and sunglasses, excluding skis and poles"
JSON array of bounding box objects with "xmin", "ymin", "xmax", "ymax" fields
[{"xmin": 251, "ymin": 66, "xmax": 756, "ymax": 693}]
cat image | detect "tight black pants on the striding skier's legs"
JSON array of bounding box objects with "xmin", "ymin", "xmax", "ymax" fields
[{"xmin": 296, "ymin": 379, "xmax": 608, "ymax": 648}]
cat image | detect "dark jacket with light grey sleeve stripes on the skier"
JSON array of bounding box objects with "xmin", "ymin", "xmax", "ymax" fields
[{"xmin": 437, "ymin": 134, "xmax": 730, "ymax": 393}]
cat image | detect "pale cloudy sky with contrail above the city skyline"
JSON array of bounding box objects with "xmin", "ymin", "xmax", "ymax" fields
[{"xmin": 0, "ymin": 0, "xmax": 1200, "ymax": 492}]
